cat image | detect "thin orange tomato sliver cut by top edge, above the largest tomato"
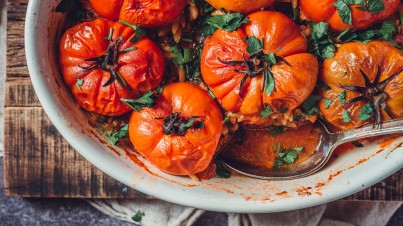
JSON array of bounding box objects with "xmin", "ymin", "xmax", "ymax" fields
[{"xmin": 206, "ymin": 0, "xmax": 274, "ymax": 14}]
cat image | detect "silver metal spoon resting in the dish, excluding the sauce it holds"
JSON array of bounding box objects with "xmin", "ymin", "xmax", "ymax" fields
[{"xmin": 221, "ymin": 119, "xmax": 403, "ymax": 180}]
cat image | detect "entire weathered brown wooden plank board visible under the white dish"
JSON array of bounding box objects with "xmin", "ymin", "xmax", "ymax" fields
[{"xmin": 4, "ymin": 0, "xmax": 403, "ymax": 200}]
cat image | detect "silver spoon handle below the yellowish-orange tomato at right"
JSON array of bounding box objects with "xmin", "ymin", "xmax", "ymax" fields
[{"xmin": 335, "ymin": 119, "xmax": 403, "ymax": 144}]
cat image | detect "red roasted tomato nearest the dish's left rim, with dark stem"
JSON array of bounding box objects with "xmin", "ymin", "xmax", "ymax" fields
[{"xmin": 59, "ymin": 20, "xmax": 164, "ymax": 116}]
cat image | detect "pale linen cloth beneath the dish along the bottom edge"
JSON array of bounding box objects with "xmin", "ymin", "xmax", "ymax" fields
[{"xmin": 87, "ymin": 199, "xmax": 403, "ymax": 226}]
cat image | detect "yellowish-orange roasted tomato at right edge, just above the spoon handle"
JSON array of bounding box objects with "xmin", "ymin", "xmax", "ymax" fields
[{"xmin": 319, "ymin": 41, "xmax": 403, "ymax": 130}]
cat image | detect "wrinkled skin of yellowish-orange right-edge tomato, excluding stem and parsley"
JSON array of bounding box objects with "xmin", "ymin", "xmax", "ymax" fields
[{"xmin": 319, "ymin": 41, "xmax": 403, "ymax": 130}]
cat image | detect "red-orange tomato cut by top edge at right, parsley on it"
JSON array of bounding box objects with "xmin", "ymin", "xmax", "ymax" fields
[{"xmin": 299, "ymin": 0, "xmax": 400, "ymax": 31}]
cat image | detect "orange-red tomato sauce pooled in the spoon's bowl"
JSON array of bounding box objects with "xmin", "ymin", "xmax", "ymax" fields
[{"xmin": 222, "ymin": 124, "xmax": 320, "ymax": 168}]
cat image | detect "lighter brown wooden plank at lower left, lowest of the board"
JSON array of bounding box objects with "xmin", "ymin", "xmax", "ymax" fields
[{"xmin": 4, "ymin": 107, "xmax": 146, "ymax": 198}]
